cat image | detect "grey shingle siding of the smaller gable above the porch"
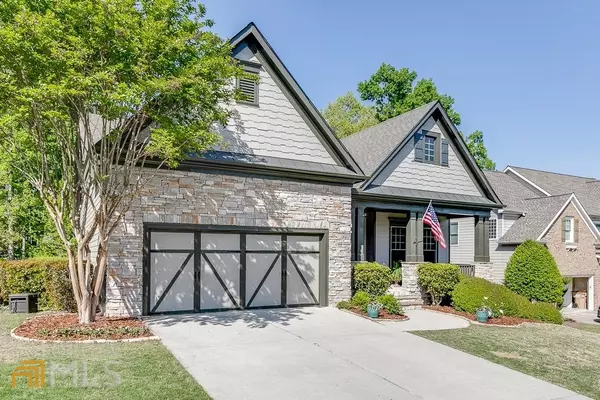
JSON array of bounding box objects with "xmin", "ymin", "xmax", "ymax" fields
[{"xmin": 373, "ymin": 117, "xmax": 483, "ymax": 196}]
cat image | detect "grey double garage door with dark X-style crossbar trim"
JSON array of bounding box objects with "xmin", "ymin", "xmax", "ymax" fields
[{"xmin": 144, "ymin": 226, "xmax": 327, "ymax": 314}]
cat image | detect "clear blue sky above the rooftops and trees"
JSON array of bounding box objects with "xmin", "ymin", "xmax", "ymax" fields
[{"xmin": 203, "ymin": 0, "xmax": 600, "ymax": 178}]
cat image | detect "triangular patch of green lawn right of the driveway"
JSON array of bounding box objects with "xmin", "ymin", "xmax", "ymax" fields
[{"xmin": 412, "ymin": 324, "xmax": 600, "ymax": 399}]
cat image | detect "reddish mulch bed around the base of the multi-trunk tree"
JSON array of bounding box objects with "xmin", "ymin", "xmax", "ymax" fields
[{"xmin": 14, "ymin": 314, "xmax": 153, "ymax": 341}]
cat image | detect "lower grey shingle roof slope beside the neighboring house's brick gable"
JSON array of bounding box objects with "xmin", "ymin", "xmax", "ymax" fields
[{"xmin": 498, "ymin": 193, "xmax": 572, "ymax": 243}]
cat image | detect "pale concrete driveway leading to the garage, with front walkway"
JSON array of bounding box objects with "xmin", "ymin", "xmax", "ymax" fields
[{"xmin": 148, "ymin": 308, "xmax": 585, "ymax": 400}]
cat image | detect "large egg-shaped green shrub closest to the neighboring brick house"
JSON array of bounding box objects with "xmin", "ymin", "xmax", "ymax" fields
[{"xmin": 504, "ymin": 240, "xmax": 564, "ymax": 304}]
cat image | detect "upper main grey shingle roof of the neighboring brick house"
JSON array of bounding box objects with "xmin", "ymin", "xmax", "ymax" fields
[{"xmin": 510, "ymin": 166, "xmax": 600, "ymax": 217}]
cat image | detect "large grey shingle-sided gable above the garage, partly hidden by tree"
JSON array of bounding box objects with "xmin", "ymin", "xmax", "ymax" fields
[{"xmin": 222, "ymin": 23, "xmax": 362, "ymax": 175}]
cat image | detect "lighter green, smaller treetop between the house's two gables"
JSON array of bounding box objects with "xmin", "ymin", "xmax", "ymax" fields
[{"xmin": 323, "ymin": 92, "xmax": 378, "ymax": 138}]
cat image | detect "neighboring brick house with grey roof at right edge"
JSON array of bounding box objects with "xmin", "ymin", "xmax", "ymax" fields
[{"xmin": 486, "ymin": 167, "xmax": 600, "ymax": 310}]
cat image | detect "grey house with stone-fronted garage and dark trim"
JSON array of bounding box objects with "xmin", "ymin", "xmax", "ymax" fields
[{"xmin": 106, "ymin": 24, "xmax": 502, "ymax": 315}]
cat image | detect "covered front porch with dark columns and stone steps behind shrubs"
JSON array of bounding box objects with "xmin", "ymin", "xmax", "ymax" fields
[{"xmin": 352, "ymin": 198, "xmax": 493, "ymax": 309}]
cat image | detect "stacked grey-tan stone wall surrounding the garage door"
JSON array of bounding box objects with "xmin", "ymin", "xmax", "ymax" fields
[{"xmin": 106, "ymin": 171, "xmax": 351, "ymax": 315}]
